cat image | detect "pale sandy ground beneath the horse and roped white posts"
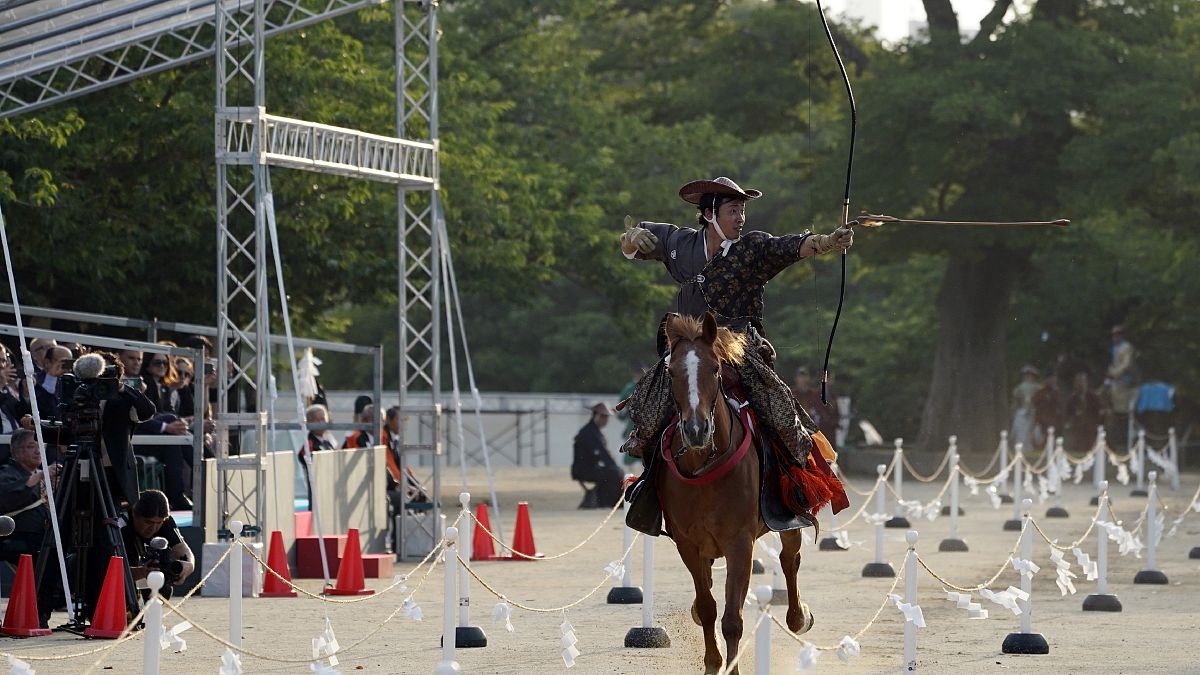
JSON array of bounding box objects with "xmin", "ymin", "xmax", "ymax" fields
[{"xmin": 4, "ymin": 461, "xmax": 1200, "ymax": 674}]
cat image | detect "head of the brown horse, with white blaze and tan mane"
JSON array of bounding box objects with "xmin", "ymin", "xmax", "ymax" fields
[{"xmin": 666, "ymin": 312, "xmax": 744, "ymax": 450}]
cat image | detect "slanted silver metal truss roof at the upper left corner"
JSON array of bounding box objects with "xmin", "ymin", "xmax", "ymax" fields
[{"xmin": 0, "ymin": 0, "xmax": 382, "ymax": 119}]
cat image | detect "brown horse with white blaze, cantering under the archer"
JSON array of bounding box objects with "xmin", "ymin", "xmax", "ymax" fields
[{"xmin": 655, "ymin": 312, "xmax": 812, "ymax": 673}]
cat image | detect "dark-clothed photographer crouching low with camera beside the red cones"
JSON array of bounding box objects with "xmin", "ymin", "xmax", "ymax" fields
[{"xmin": 121, "ymin": 490, "xmax": 196, "ymax": 598}]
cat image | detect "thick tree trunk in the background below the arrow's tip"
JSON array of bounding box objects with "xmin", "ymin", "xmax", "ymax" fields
[{"xmin": 916, "ymin": 247, "xmax": 1022, "ymax": 464}]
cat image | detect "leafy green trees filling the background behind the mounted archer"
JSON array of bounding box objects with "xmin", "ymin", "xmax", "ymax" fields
[{"xmin": 0, "ymin": 0, "xmax": 1200, "ymax": 449}]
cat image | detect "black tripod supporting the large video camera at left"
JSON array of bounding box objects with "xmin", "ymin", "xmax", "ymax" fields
[{"xmin": 35, "ymin": 441, "xmax": 140, "ymax": 632}]
